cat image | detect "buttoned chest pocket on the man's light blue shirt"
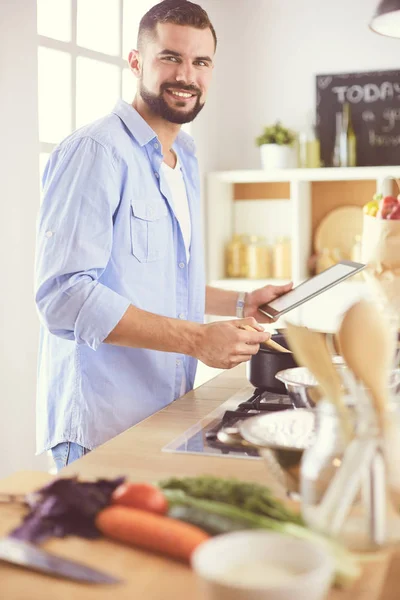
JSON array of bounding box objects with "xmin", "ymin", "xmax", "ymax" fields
[{"xmin": 131, "ymin": 201, "xmax": 171, "ymax": 262}]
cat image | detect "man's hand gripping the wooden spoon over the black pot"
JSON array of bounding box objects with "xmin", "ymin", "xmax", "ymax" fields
[{"xmin": 193, "ymin": 318, "xmax": 270, "ymax": 369}]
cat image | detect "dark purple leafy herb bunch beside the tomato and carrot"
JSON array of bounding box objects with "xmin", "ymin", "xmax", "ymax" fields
[{"xmin": 9, "ymin": 477, "xmax": 125, "ymax": 544}]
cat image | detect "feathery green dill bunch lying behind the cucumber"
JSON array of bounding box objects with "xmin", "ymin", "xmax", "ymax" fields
[{"xmin": 159, "ymin": 475, "xmax": 303, "ymax": 525}]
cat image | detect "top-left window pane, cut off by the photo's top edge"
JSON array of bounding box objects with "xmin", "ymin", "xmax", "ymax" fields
[{"xmin": 37, "ymin": 0, "xmax": 71, "ymax": 42}]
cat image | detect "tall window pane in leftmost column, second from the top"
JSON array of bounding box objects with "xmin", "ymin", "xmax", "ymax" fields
[{"xmin": 38, "ymin": 46, "xmax": 71, "ymax": 144}]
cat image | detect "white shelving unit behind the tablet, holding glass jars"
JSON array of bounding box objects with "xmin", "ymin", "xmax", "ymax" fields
[{"xmin": 206, "ymin": 167, "xmax": 400, "ymax": 330}]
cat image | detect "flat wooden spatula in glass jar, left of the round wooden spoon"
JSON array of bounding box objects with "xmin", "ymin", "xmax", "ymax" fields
[{"xmin": 286, "ymin": 323, "xmax": 353, "ymax": 439}]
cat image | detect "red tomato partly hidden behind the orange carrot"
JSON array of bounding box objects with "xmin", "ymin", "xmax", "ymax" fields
[{"xmin": 111, "ymin": 483, "xmax": 168, "ymax": 515}]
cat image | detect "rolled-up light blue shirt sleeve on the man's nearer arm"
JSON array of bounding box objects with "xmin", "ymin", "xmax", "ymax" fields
[{"xmin": 35, "ymin": 137, "xmax": 130, "ymax": 350}]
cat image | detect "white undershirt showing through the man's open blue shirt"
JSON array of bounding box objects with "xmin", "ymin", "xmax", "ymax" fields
[{"xmin": 161, "ymin": 157, "xmax": 192, "ymax": 396}]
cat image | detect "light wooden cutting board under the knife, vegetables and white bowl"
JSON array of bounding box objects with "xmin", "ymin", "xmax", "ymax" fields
[{"xmin": 0, "ymin": 471, "xmax": 400, "ymax": 600}]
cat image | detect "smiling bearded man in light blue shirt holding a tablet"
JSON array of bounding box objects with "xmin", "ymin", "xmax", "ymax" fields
[{"xmin": 36, "ymin": 0, "xmax": 290, "ymax": 468}]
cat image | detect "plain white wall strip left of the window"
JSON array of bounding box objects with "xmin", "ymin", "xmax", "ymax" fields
[{"xmin": 0, "ymin": 0, "xmax": 46, "ymax": 477}]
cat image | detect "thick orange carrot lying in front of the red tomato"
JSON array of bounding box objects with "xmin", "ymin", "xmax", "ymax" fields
[{"xmin": 95, "ymin": 505, "xmax": 210, "ymax": 562}]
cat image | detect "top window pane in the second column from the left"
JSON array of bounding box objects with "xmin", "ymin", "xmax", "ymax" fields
[{"xmin": 77, "ymin": 0, "xmax": 120, "ymax": 56}]
